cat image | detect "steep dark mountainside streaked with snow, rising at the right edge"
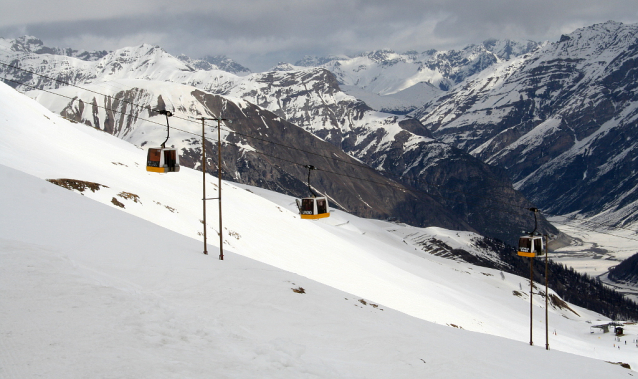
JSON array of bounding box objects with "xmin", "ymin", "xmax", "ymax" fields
[{"xmin": 412, "ymin": 21, "xmax": 638, "ymax": 229}]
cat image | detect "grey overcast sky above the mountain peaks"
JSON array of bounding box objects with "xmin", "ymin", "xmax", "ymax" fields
[{"xmin": 0, "ymin": 0, "xmax": 638, "ymax": 71}]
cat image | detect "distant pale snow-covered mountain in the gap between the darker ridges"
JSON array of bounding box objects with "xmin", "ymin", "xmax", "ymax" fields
[{"xmin": 292, "ymin": 40, "xmax": 541, "ymax": 114}]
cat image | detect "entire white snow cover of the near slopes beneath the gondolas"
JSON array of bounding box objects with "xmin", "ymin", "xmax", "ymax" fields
[{"xmin": 0, "ymin": 84, "xmax": 638, "ymax": 379}]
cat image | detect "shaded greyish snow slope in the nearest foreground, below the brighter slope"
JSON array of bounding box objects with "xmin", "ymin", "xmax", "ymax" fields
[{"xmin": 0, "ymin": 166, "xmax": 628, "ymax": 378}]
